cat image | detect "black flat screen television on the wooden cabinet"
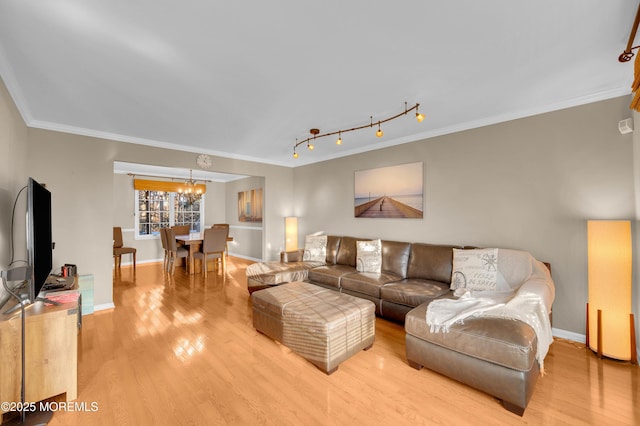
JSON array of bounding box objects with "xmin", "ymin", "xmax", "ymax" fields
[{"xmin": 27, "ymin": 178, "xmax": 53, "ymax": 303}]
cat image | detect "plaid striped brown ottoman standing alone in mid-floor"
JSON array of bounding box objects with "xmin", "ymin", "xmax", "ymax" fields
[{"xmin": 251, "ymin": 282, "xmax": 375, "ymax": 374}]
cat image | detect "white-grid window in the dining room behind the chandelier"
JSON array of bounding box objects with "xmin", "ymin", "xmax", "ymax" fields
[{"xmin": 134, "ymin": 190, "xmax": 204, "ymax": 239}]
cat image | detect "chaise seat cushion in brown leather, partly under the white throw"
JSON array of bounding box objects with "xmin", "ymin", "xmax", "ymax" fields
[{"xmin": 404, "ymin": 302, "xmax": 538, "ymax": 371}]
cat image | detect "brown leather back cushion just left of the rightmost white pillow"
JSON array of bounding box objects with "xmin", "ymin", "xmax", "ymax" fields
[{"xmin": 407, "ymin": 243, "xmax": 459, "ymax": 284}]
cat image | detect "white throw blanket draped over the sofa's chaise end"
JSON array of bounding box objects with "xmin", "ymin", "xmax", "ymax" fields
[{"xmin": 426, "ymin": 251, "xmax": 555, "ymax": 374}]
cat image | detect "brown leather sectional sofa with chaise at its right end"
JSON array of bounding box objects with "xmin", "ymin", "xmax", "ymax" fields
[{"xmin": 247, "ymin": 236, "xmax": 553, "ymax": 415}]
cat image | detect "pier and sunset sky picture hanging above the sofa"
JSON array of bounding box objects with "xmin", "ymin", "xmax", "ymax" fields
[{"xmin": 353, "ymin": 162, "xmax": 424, "ymax": 219}]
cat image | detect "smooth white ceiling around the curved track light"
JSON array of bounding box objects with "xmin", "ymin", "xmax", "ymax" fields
[{"xmin": 0, "ymin": 0, "xmax": 638, "ymax": 166}]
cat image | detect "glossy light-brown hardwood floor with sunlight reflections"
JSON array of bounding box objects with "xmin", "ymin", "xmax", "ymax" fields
[{"xmin": 50, "ymin": 258, "xmax": 640, "ymax": 425}]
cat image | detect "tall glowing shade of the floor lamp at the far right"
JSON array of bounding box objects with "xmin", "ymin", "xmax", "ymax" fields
[{"xmin": 587, "ymin": 220, "xmax": 632, "ymax": 360}]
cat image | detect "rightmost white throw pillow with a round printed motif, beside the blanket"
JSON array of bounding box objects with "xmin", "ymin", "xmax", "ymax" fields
[{"xmin": 451, "ymin": 248, "xmax": 498, "ymax": 291}]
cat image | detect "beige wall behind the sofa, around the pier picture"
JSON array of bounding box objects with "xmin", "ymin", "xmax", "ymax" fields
[{"xmin": 294, "ymin": 97, "xmax": 638, "ymax": 334}]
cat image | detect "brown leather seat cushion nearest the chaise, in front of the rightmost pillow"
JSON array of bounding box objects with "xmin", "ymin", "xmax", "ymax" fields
[{"xmin": 380, "ymin": 278, "xmax": 450, "ymax": 307}]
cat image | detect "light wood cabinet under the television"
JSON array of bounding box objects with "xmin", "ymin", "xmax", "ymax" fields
[{"xmin": 0, "ymin": 290, "xmax": 81, "ymax": 412}]
